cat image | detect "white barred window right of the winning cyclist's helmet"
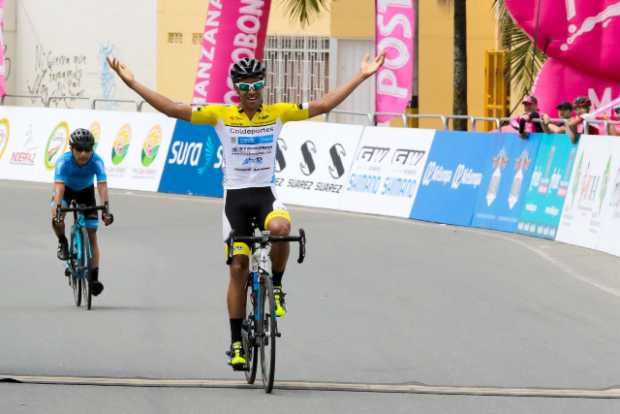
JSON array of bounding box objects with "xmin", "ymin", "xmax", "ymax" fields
[{"xmin": 265, "ymin": 36, "xmax": 329, "ymax": 103}]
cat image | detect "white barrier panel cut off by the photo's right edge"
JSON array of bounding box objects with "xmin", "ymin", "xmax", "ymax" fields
[{"xmin": 598, "ymin": 137, "xmax": 620, "ymax": 256}]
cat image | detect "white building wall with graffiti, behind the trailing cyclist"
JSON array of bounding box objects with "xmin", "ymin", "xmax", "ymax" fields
[{"xmin": 7, "ymin": 0, "xmax": 157, "ymax": 108}]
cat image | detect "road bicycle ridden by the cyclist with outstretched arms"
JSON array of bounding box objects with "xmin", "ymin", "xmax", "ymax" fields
[{"xmin": 226, "ymin": 229, "xmax": 306, "ymax": 393}]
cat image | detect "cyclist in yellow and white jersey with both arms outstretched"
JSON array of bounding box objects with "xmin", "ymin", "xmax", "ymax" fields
[{"xmin": 108, "ymin": 53, "xmax": 385, "ymax": 369}]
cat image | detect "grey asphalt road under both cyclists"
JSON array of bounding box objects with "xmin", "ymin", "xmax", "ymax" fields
[{"xmin": 0, "ymin": 182, "xmax": 620, "ymax": 413}]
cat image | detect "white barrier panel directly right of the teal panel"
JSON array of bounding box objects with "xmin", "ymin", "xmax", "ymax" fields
[{"xmin": 556, "ymin": 135, "xmax": 617, "ymax": 249}]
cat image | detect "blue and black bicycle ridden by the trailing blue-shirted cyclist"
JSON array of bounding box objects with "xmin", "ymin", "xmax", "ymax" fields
[{"xmin": 56, "ymin": 201, "xmax": 107, "ymax": 310}]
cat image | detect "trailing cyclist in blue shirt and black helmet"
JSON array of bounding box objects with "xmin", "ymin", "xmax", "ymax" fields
[{"xmin": 52, "ymin": 129, "xmax": 114, "ymax": 296}]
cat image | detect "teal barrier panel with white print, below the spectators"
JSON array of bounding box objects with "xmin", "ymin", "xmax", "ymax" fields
[{"xmin": 517, "ymin": 134, "xmax": 577, "ymax": 239}]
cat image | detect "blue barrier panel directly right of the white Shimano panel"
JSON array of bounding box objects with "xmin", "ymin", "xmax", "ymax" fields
[{"xmin": 410, "ymin": 131, "xmax": 501, "ymax": 226}]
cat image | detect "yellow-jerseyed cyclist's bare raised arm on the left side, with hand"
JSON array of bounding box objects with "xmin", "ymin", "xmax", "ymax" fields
[{"xmin": 108, "ymin": 57, "xmax": 192, "ymax": 121}]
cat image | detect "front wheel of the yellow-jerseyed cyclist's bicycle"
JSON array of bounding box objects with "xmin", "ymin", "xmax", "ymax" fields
[{"xmin": 257, "ymin": 275, "xmax": 278, "ymax": 393}]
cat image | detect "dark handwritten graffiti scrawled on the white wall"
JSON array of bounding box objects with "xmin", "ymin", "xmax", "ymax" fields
[{"xmin": 26, "ymin": 45, "xmax": 87, "ymax": 107}]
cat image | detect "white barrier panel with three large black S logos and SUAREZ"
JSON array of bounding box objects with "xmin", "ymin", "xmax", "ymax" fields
[{"xmin": 276, "ymin": 122, "xmax": 363, "ymax": 209}]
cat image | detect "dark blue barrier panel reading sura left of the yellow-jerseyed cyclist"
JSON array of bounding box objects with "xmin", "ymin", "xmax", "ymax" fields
[{"xmin": 159, "ymin": 121, "xmax": 224, "ymax": 197}]
